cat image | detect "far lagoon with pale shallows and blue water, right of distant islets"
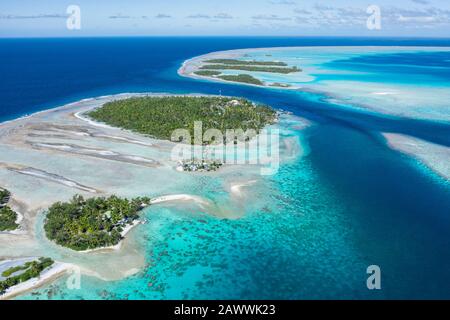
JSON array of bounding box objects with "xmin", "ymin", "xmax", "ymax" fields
[{"xmin": 223, "ymin": 46, "xmax": 450, "ymax": 121}]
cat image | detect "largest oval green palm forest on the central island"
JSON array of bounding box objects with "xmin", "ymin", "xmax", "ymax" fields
[{"xmin": 88, "ymin": 96, "xmax": 276, "ymax": 143}]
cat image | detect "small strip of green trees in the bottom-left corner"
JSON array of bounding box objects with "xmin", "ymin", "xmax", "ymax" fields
[{"xmin": 0, "ymin": 258, "xmax": 54, "ymax": 295}]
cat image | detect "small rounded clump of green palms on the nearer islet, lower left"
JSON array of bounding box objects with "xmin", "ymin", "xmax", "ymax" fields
[{"xmin": 44, "ymin": 195, "xmax": 150, "ymax": 251}]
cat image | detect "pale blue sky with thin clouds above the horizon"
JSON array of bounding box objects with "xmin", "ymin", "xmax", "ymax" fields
[{"xmin": 0, "ymin": 0, "xmax": 450, "ymax": 38}]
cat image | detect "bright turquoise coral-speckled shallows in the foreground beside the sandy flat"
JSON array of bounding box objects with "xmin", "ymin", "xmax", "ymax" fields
[{"xmin": 22, "ymin": 123, "xmax": 376, "ymax": 299}]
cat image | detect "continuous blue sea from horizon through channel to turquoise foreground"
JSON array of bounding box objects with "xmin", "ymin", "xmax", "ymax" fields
[{"xmin": 0, "ymin": 38, "xmax": 450, "ymax": 299}]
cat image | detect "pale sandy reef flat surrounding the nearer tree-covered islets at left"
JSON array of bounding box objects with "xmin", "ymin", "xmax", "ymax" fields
[{"xmin": 0, "ymin": 93, "xmax": 302, "ymax": 298}]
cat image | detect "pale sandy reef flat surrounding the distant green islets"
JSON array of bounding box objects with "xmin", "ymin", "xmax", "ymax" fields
[{"xmin": 178, "ymin": 46, "xmax": 450, "ymax": 123}]
